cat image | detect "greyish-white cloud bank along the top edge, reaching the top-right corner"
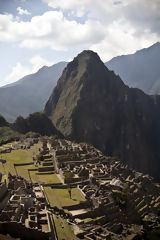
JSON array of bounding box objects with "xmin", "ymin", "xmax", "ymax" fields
[{"xmin": 43, "ymin": 0, "xmax": 160, "ymax": 34}]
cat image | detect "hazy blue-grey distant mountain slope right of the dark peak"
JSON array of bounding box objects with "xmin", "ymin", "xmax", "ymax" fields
[{"xmin": 105, "ymin": 42, "xmax": 160, "ymax": 94}]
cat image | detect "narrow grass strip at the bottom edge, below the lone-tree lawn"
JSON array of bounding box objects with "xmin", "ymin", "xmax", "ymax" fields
[{"xmin": 53, "ymin": 215, "xmax": 79, "ymax": 240}]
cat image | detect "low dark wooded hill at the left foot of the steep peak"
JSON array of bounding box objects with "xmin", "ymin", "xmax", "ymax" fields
[{"xmin": 12, "ymin": 112, "xmax": 62, "ymax": 137}]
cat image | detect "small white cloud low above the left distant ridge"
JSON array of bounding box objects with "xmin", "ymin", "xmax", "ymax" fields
[{"xmin": 3, "ymin": 55, "xmax": 54, "ymax": 85}]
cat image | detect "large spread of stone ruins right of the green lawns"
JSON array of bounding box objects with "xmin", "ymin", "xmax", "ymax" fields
[{"xmin": 44, "ymin": 140, "xmax": 160, "ymax": 240}]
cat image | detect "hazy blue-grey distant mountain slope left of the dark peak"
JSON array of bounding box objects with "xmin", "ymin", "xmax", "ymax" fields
[{"xmin": 0, "ymin": 62, "xmax": 66, "ymax": 122}]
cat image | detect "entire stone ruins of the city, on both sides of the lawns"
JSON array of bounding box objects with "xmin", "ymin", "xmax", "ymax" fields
[{"xmin": 0, "ymin": 139, "xmax": 160, "ymax": 240}]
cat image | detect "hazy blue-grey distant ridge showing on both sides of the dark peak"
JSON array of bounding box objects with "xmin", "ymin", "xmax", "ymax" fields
[{"xmin": 0, "ymin": 43, "xmax": 160, "ymax": 122}]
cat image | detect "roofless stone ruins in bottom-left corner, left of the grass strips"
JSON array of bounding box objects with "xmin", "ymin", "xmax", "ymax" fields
[{"xmin": 0, "ymin": 174, "xmax": 57, "ymax": 240}]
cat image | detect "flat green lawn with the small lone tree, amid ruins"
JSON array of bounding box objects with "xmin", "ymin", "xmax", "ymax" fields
[{"xmin": 44, "ymin": 187, "xmax": 84, "ymax": 208}]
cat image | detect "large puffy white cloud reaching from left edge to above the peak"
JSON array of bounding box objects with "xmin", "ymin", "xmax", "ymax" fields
[{"xmin": 0, "ymin": 11, "xmax": 105, "ymax": 50}]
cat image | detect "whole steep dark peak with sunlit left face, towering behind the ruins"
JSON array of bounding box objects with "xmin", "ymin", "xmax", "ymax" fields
[{"xmin": 44, "ymin": 51, "xmax": 160, "ymax": 178}]
